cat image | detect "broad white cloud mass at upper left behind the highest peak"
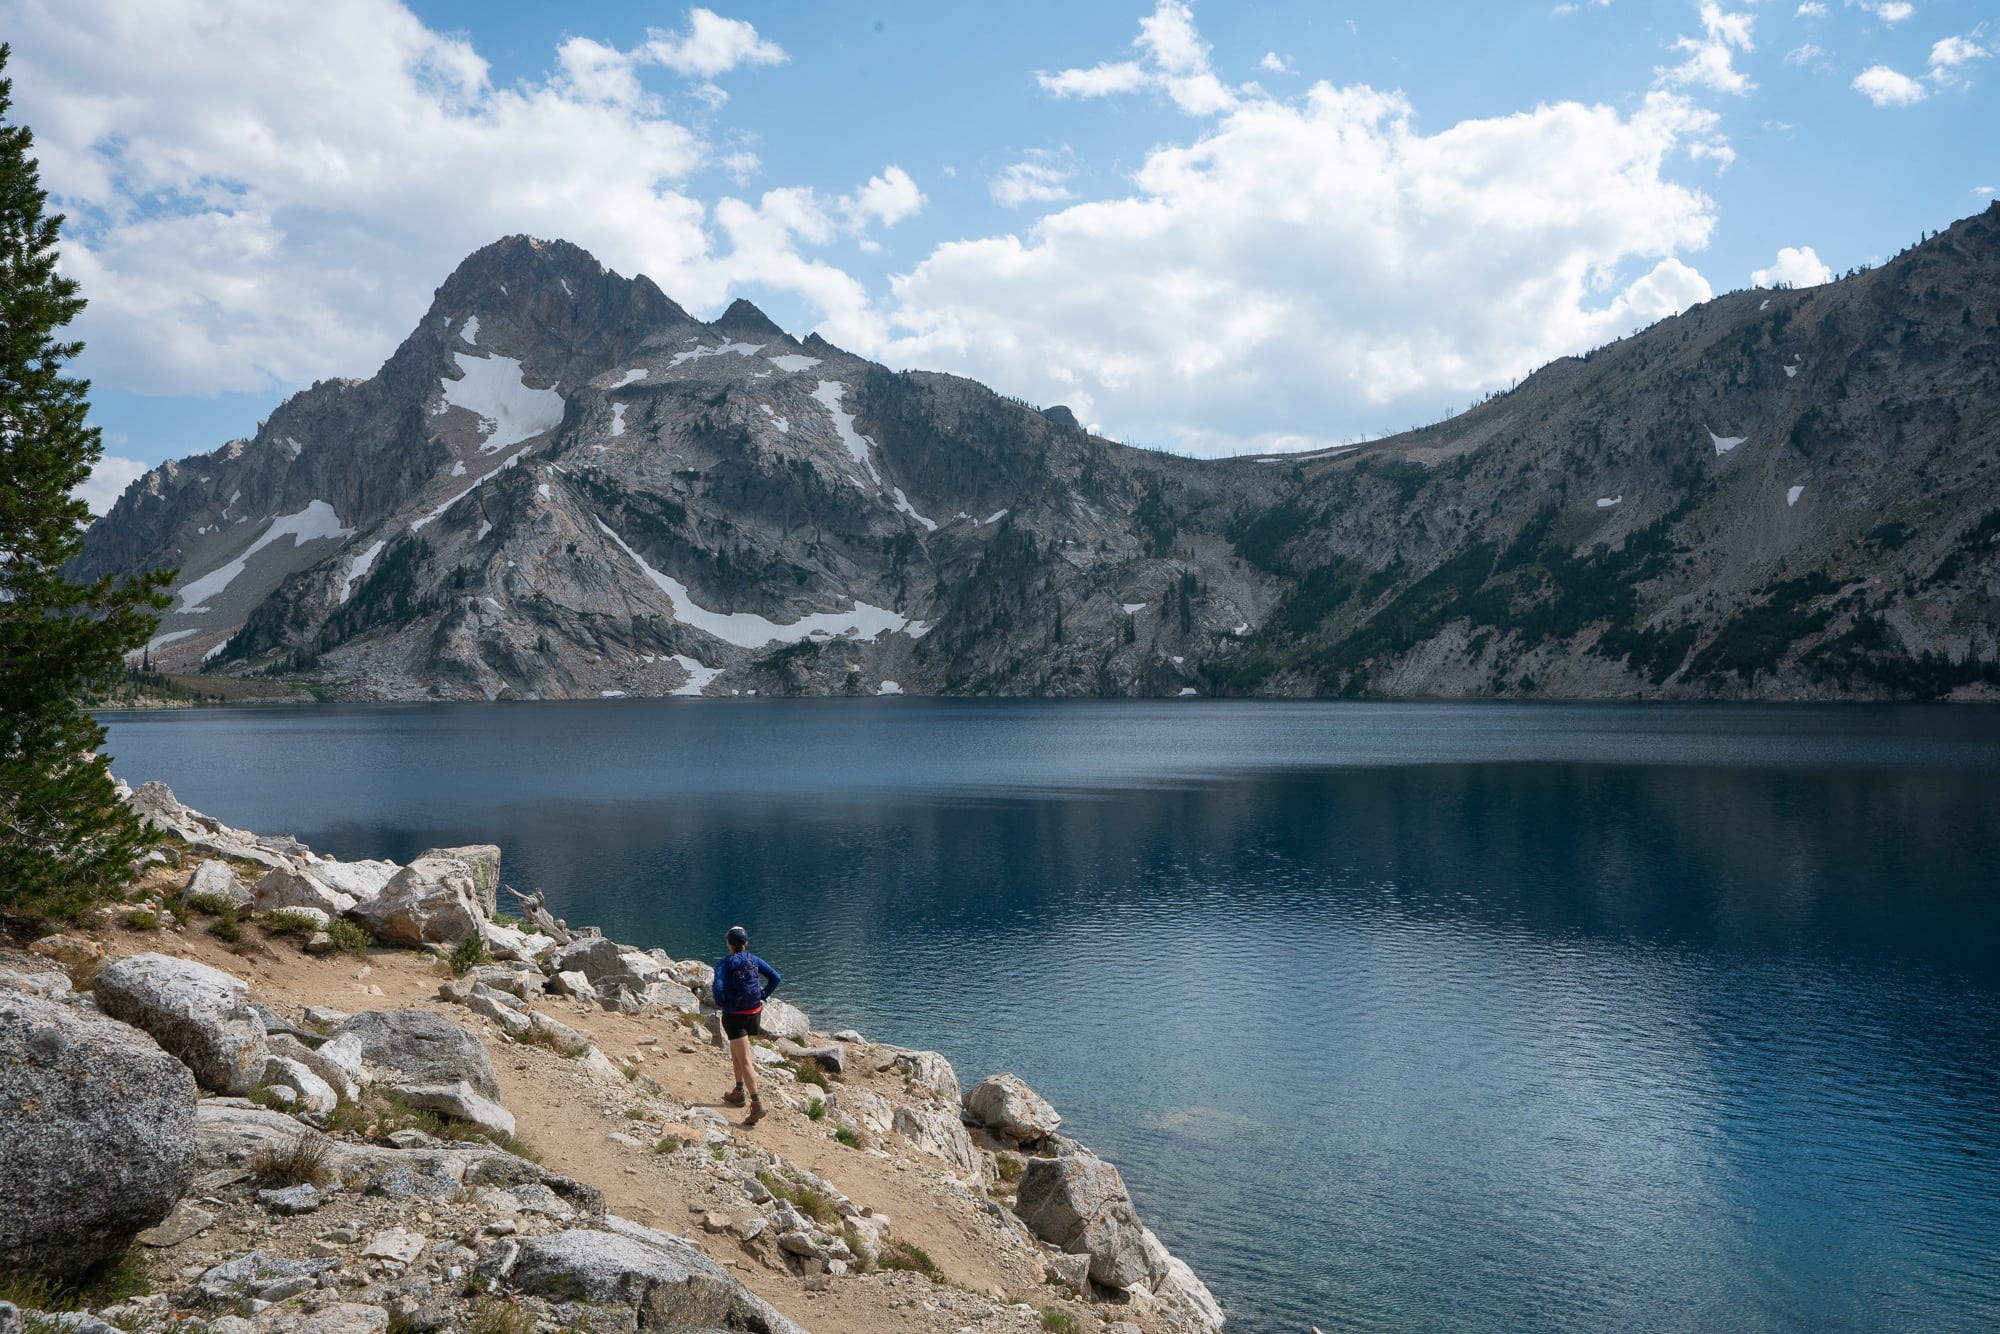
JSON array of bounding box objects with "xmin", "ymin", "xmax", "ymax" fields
[{"xmin": 8, "ymin": 0, "xmax": 922, "ymax": 394}]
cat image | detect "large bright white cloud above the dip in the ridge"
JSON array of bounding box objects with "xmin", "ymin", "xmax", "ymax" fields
[{"xmin": 844, "ymin": 84, "xmax": 1714, "ymax": 452}]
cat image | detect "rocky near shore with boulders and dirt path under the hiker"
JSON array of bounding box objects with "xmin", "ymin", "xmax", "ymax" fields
[{"xmin": 0, "ymin": 784, "xmax": 1224, "ymax": 1334}]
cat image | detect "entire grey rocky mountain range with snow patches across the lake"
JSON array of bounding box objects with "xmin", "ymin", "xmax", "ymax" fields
[{"xmin": 78, "ymin": 208, "xmax": 2000, "ymax": 698}]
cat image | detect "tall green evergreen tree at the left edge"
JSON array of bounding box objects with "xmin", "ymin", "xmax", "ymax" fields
[{"xmin": 0, "ymin": 44, "xmax": 174, "ymax": 916}]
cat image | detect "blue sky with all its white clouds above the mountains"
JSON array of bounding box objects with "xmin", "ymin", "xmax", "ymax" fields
[{"xmin": 0, "ymin": 0, "xmax": 2000, "ymax": 508}]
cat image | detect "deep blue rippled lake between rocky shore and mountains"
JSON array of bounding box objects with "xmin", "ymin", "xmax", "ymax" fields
[{"xmin": 106, "ymin": 700, "xmax": 2000, "ymax": 1334}]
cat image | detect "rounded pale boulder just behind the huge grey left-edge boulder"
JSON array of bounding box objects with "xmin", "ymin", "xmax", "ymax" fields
[{"xmin": 94, "ymin": 954, "xmax": 270, "ymax": 1096}]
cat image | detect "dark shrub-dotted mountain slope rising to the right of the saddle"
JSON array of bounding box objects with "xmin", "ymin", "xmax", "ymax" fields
[{"xmin": 1206, "ymin": 206, "xmax": 2000, "ymax": 698}]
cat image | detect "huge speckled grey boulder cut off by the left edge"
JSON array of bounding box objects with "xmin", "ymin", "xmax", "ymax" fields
[{"xmin": 0, "ymin": 988, "xmax": 196, "ymax": 1282}]
